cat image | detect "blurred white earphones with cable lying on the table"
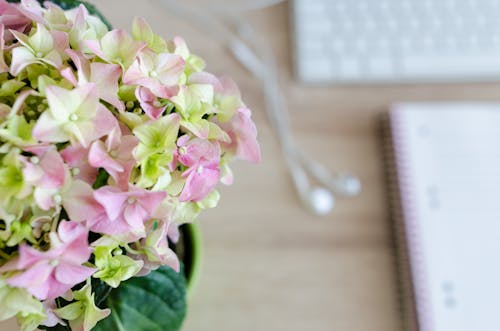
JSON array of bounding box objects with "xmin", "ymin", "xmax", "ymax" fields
[{"xmin": 154, "ymin": 0, "xmax": 361, "ymax": 215}]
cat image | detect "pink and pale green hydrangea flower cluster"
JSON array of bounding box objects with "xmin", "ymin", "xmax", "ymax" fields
[{"xmin": 0, "ymin": 0, "xmax": 260, "ymax": 330}]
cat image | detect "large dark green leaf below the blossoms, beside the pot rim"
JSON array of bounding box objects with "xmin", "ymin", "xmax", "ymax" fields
[{"xmin": 93, "ymin": 267, "xmax": 186, "ymax": 331}]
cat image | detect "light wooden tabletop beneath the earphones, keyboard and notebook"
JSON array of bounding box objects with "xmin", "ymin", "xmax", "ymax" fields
[{"xmin": 0, "ymin": 0, "xmax": 500, "ymax": 331}]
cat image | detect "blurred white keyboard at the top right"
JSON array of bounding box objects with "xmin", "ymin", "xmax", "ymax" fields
[{"xmin": 292, "ymin": 0, "xmax": 500, "ymax": 83}]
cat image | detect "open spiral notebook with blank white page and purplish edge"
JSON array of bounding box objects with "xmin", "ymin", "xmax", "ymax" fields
[{"xmin": 386, "ymin": 103, "xmax": 500, "ymax": 331}]
